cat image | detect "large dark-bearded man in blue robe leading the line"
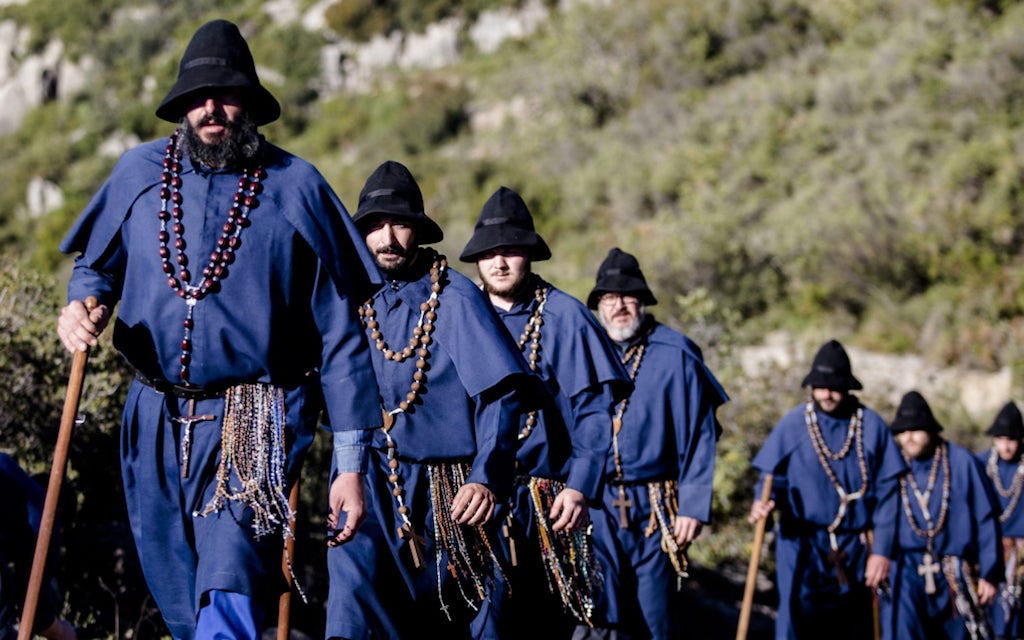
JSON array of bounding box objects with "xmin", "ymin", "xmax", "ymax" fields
[{"xmin": 57, "ymin": 20, "xmax": 381, "ymax": 640}]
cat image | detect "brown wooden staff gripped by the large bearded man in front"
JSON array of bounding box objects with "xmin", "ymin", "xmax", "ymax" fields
[{"xmin": 17, "ymin": 296, "xmax": 98, "ymax": 640}]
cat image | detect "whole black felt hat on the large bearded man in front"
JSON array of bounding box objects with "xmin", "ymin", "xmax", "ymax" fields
[{"xmin": 157, "ymin": 20, "xmax": 281, "ymax": 126}]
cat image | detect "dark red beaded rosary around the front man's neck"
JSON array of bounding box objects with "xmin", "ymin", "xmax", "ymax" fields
[{"xmin": 158, "ymin": 130, "xmax": 266, "ymax": 385}]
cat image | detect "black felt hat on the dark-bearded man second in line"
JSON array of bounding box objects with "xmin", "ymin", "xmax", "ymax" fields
[{"xmin": 352, "ymin": 160, "xmax": 444, "ymax": 245}]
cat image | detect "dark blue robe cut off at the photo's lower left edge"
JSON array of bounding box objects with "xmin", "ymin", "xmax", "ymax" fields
[{"xmin": 0, "ymin": 453, "xmax": 60, "ymax": 638}]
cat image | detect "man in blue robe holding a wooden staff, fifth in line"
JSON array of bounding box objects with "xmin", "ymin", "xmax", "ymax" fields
[{"xmin": 749, "ymin": 340, "xmax": 906, "ymax": 639}]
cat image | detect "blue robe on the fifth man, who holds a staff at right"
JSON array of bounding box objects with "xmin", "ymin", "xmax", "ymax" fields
[{"xmin": 752, "ymin": 396, "xmax": 906, "ymax": 639}]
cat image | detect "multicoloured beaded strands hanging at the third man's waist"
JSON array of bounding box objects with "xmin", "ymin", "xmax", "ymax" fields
[{"xmin": 529, "ymin": 477, "xmax": 602, "ymax": 627}]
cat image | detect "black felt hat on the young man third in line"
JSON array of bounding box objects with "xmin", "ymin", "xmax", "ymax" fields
[{"xmin": 459, "ymin": 186, "xmax": 551, "ymax": 262}]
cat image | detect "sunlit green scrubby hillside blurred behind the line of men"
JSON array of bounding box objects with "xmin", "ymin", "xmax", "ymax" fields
[{"xmin": 0, "ymin": 0, "xmax": 1024, "ymax": 637}]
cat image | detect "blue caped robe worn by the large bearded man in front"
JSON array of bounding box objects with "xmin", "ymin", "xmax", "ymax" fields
[{"xmin": 60, "ymin": 140, "xmax": 381, "ymax": 639}]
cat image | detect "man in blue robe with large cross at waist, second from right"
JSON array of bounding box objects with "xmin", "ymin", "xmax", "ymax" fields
[{"xmin": 881, "ymin": 391, "xmax": 1002, "ymax": 640}]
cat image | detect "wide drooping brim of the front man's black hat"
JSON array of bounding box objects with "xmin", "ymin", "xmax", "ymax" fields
[{"xmin": 157, "ymin": 67, "xmax": 281, "ymax": 126}]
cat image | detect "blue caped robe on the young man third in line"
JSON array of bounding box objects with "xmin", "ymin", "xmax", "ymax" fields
[{"xmin": 473, "ymin": 278, "xmax": 633, "ymax": 638}]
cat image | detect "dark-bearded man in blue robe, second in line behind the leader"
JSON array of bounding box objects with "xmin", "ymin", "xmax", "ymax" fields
[{"xmin": 327, "ymin": 161, "xmax": 543, "ymax": 639}]
